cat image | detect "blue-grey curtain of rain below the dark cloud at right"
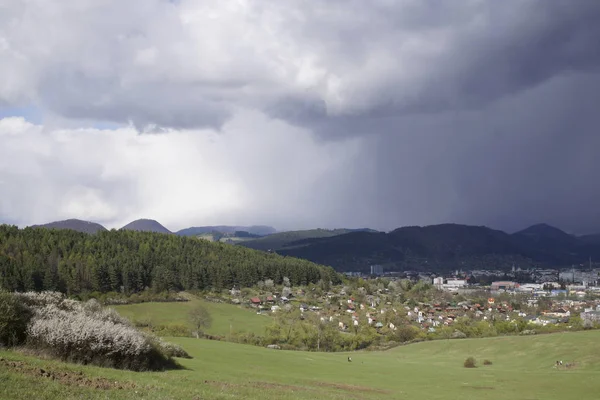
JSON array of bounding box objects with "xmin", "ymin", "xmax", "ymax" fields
[{"xmin": 344, "ymin": 75, "xmax": 600, "ymax": 233}]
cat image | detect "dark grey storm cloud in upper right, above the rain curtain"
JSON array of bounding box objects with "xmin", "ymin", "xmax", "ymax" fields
[{"xmin": 267, "ymin": 0, "xmax": 600, "ymax": 137}]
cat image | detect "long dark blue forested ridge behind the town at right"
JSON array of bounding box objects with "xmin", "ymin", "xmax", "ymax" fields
[{"xmin": 268, "ymin": 224, "xmax": 600, "ymax": 271}]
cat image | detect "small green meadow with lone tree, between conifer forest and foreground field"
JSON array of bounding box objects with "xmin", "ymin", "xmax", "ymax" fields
[{"xmin": 114, "ymin": 298, "xmax": 273, "ymax": 336}]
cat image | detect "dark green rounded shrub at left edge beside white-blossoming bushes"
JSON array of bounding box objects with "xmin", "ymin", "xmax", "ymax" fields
[{"xmin": 0, "ymin": 292, "xmax": 31, "ymax": 347}]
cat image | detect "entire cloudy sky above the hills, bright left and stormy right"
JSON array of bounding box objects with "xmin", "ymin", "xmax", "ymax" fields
[{"xmin": 0, "ymin": 0, "xmax": 600, "ymax": 234}]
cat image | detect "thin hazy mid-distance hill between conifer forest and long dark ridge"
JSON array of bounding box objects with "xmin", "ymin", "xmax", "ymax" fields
[{"xmin": 241, "ymin": 228, "xmax": 376, "ymax": 250}]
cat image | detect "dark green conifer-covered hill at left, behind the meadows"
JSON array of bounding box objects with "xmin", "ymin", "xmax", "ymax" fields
[{"xmin": 0, "ymin": 225, "xmax": 339, "ymax": 294}]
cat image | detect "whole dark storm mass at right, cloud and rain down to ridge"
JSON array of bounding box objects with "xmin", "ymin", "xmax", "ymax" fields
[{"xmin": 258, "ymin": 1, "xmax": 600, "ymax": 233}]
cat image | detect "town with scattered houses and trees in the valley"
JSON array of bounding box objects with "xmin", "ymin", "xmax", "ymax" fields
[{"xmin": 218, "ymin": 266, "xmax": 600, "ymax": 350}]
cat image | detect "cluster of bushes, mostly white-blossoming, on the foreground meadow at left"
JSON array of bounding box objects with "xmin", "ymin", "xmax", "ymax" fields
[{"xmin": 0, "ymin": 292, "xmax": 189, "ymax": 371}]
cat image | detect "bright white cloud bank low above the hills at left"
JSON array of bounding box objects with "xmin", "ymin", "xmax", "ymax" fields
[{"xmin": 0, "ymin": 112, "xmax": 359, "ymax": 229}]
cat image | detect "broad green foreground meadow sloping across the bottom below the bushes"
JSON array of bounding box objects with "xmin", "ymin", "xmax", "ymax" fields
[{"xmin": 0, "ymin": 331, "xmax": 600, "ymax": 400}]
